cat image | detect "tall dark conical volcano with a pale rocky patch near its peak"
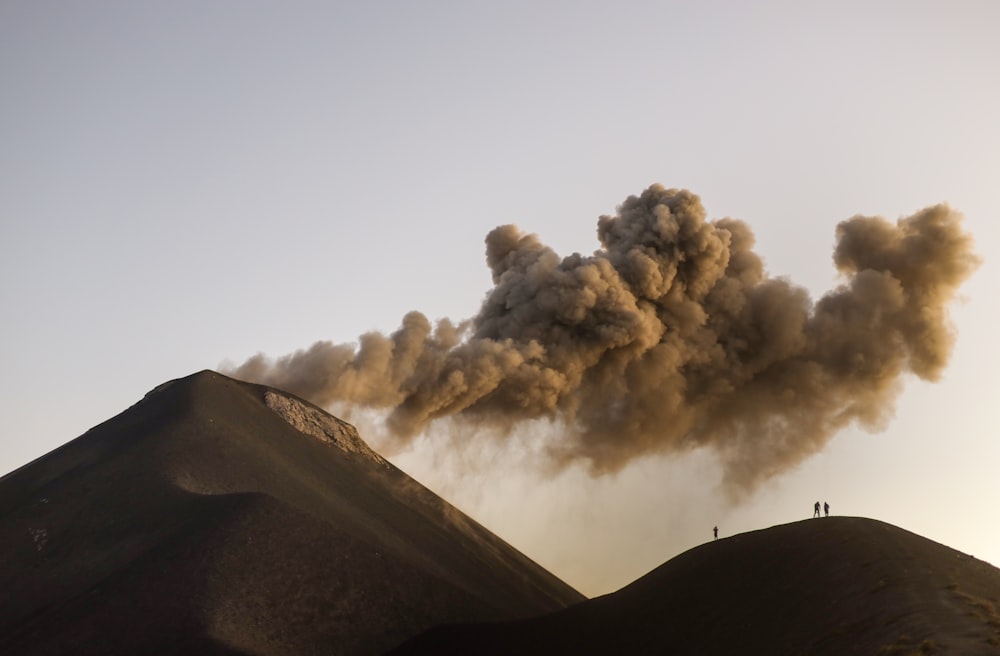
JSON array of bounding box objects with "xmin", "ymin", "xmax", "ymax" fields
[{"xmin": 0, "ymin": 371, "xmax": 584, "ymax": 656}]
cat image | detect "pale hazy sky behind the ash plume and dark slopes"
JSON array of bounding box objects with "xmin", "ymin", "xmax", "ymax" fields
[{"xmin": 0, "ymin": 0, "xmax": 1000, "ymax": 595}]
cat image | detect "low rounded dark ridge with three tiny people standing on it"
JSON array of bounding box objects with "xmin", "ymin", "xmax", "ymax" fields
[{"xmin": 390, "ymin": 517, "xmax": 1000, "ymax": 656}]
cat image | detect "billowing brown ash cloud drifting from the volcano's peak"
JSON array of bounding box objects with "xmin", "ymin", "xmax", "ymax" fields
[{"xmin": 231, "ymin": 185, "xmax": 978, "ymax": 489}]
